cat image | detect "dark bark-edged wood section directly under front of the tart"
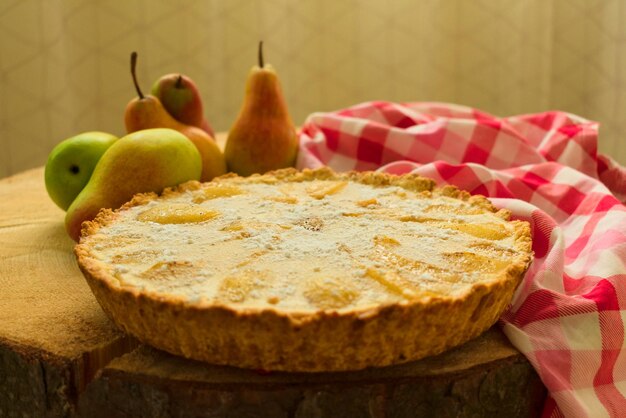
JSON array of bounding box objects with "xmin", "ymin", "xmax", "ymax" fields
[{"xmin": 79, "ymin": 329, "xmax": 545, "ymax": 418}]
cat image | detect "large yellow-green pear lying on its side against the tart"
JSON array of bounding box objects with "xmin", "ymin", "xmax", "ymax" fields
[{"xmin": 65, "ymin": 128, "xmax": 202, "ymax": 241}]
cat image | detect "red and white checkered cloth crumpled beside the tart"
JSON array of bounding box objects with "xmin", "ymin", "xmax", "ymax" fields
[{"xmin": 298, "ymin": 102, "xmax": 626, "ymax": 417}]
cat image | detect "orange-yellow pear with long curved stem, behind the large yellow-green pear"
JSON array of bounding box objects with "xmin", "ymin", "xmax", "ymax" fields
[{"xmin": 124, "ymin": 52, "xmax": 226, "ymax": 181}]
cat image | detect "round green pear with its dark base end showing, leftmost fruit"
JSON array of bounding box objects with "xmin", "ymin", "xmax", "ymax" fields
[{"xmin": 44, "ymin": 131, "xmax": 117, "ymax": 210}]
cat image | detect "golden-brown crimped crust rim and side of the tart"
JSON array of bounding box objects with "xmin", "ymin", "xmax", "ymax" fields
[{"xmin": 75, "ymin": 168, "xmax": 532, "ymax": 372}]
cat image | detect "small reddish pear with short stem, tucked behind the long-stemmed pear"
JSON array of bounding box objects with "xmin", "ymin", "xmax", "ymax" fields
[{"xmin": 152, "ymin": 73, "xmax": 215, "ymax": 138}]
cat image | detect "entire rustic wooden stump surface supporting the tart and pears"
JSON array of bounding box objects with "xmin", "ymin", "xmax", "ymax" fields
[{"xmin": 0, "ymin": 168, "xmax": 545, "ymax": 417}]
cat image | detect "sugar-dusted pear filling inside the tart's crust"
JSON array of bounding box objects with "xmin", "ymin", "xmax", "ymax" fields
[{"xmin": 85, "ymin": 180, "xmax": 515, "ymax": 310}]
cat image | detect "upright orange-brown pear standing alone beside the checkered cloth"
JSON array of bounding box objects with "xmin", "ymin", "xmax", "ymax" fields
[{"xmin": 224, "ymin": 42, "xmax": 298, "ymax": 176}]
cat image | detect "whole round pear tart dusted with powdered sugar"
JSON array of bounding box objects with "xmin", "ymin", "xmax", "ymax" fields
[{"xmin": 75, "ymin": 169, "xmax": 532, "ymax": 371}]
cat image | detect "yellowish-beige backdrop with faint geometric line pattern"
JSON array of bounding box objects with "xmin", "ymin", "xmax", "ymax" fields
[{"xmin": 0, "ymin": 0, "xmax": 626, "ymax": 177}]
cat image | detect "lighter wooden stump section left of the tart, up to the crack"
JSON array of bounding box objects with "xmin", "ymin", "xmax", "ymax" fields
[{"xmin": 0, "ymin": 169, "xmax": 136, "ymax": 417}]
